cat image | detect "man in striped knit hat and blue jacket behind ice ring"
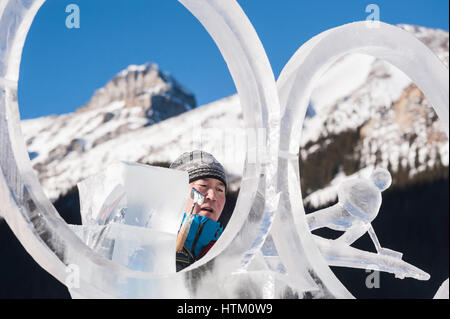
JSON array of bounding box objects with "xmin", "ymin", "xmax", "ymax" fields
[{"xmin": 170, "ymin": 150, "xmax": 227, "ymax": 271}]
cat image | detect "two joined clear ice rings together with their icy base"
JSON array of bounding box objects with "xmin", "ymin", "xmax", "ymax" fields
[{"xmin": 0, "ymin": 0, "xmax": 449, "ymax": 298}]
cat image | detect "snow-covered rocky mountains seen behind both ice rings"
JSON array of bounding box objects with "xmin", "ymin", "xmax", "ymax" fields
[{"xmin": 22, "ymin": 25, "xmax": 449, "ymax": 206}]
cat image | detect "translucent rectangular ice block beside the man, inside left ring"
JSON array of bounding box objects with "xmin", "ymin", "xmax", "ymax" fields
[{"xmin": 71, "ymin": 162, "xmax": 188, "ymax": 274}]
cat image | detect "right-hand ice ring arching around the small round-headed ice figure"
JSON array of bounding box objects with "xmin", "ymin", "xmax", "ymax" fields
[{"xmin": 277, "ymin": 21, "xmax": 449, "ymax": 297}]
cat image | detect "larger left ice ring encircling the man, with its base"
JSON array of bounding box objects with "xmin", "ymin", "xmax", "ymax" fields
[{"xmin": 0, "ymin": 0, "xmax": 286, "ymax": 298}]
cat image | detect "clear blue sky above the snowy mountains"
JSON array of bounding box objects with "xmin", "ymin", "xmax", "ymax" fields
[{"xmin": 19, "ymin": 0, "xmax": 449, "ymax": 119}]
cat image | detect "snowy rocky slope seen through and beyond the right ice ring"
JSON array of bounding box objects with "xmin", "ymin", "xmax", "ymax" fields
[{"xmin": 300, "ymin": 25, "xmax": 449, "ymax": 207}]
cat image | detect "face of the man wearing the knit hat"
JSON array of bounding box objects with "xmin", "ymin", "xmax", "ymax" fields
[{"xmin": 185, "ymin": 178, "xmax": 226, "ymax": 221}]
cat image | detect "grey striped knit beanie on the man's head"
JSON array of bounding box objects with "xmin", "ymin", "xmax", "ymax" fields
[{"xmin": 169, "ymin": 150, "xmax": 227, "ymax": 187}]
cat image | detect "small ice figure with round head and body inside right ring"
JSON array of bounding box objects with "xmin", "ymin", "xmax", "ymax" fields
[{"xmin": 306, "ymin": 168, "xmax": 430, "ymax": 280}]
